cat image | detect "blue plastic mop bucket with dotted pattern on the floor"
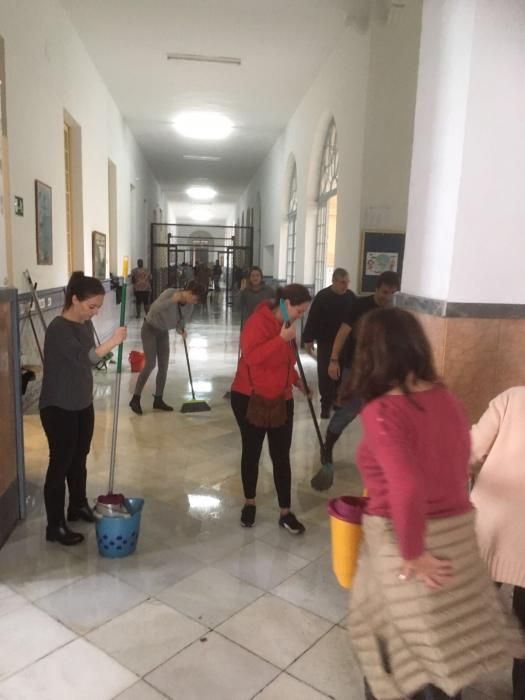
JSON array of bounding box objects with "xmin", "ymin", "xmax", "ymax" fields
[{"xmin": 96, "ymin": 498, "xmax": 144, "ymax": 559}]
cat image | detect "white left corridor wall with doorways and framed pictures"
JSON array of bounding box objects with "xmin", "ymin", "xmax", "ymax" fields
[{"xmin": 0, "ymin": 0, "xmax": 163, "ymax": 289}]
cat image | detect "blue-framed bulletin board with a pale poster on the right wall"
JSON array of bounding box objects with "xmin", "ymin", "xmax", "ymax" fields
[{"xmin": 359, "ymin": 230, "xmax": 405, "ymax": 292}]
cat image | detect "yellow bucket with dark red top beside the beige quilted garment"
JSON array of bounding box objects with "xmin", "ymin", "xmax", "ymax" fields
[{"xmin": 328, "ymin": 496, "xmax": 366, "ymax": 588}]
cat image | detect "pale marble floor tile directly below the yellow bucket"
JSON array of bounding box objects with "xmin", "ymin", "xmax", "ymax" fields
[{"xmin": 272, "ymin": 553, "xmax": 349, "ymax": 623}]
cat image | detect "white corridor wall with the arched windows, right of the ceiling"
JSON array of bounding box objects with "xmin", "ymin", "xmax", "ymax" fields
[{"xmin": 237, "ymin": 0, "xmax": 421, "ymax": 287}]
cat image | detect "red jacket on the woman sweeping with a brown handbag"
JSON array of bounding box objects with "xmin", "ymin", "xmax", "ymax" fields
[{"xmin": 232, "ymin": 301, "xmax": 299, "ymax": 399}]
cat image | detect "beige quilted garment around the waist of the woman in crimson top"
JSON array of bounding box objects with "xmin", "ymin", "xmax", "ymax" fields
[{"xmin": 349, "ymin": 512, "xmax": 525, "ymax": 700}]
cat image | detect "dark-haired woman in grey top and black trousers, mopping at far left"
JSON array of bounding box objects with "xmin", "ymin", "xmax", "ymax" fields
[{"xmin": 39, "ymin": 272, "xmax": 126, "ymax": 545}]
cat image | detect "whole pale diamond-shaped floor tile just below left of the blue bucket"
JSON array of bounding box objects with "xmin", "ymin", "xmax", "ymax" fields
[{"xmin": 37, "ymin": 573, "xmax": 147, "ymax": 634}]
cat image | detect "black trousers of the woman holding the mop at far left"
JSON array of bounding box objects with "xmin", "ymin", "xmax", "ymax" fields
[{"xmin": 40, "ymin": 404, "xmax": 95, "ymax": 526}]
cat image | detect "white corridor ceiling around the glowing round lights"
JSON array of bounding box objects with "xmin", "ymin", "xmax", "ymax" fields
[{"xmin": 61, "ymin": 0, "xmax": 356, "ymax": 222}]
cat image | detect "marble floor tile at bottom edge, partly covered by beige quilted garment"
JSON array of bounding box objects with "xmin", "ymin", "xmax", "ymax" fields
[{"xmin": 288, "ymin": 626, "xmax": 364, "ymax": 700}]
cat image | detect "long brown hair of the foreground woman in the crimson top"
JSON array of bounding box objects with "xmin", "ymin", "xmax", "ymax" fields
[{"xmin": 351, "ymin": 307, "xmax": 438, "ymax": 402}]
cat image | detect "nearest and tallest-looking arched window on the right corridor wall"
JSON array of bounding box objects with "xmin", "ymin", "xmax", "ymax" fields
[{"xmin": 315, "ymin": 119, "xmax": 339, "ymax": 292}]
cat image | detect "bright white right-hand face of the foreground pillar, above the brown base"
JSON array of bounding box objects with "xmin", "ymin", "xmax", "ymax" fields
[{"xmin": 449, "ymin": 0, "xmax": 525, "ymax": 304}]
